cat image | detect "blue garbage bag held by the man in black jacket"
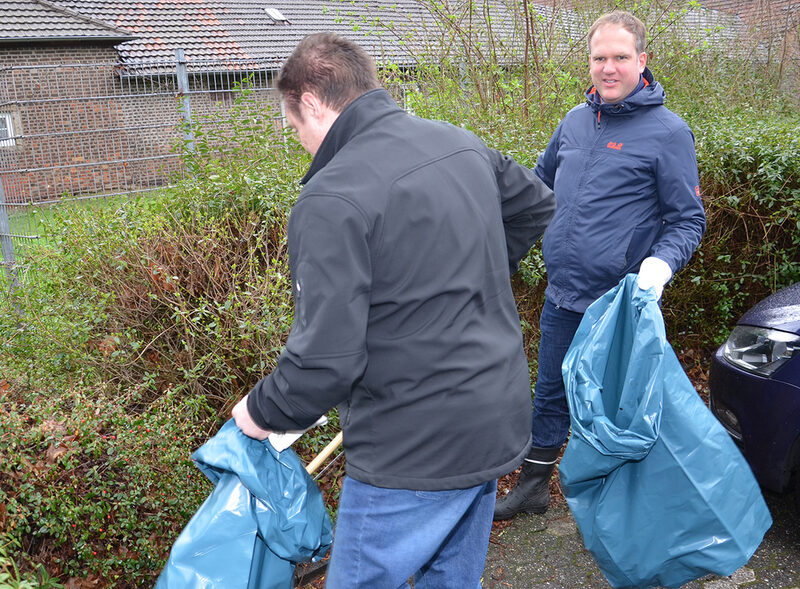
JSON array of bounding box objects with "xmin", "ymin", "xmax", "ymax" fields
[{"xmin": 156, "ymin": 419, "xmax": 332, "ymax": 589}]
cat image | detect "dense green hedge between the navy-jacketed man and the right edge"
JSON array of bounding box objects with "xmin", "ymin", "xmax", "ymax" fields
[{"xmin": 666, "ymin": 108, "xmax": 800, "ymax": 344}]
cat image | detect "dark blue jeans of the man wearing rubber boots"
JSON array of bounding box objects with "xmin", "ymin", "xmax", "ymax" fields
[{"xmin": 531, "ymin": 299, "xmax": 583, "ymax": 448}]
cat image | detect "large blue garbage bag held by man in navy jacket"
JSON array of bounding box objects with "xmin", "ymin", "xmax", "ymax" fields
[{"xmin": 559, "ymin": 274, "xmax": 772, "ymax": 587}]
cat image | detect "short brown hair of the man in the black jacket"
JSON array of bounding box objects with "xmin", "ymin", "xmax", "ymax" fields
[{"xmin": 277, "ymin": 33, "xmax": 380, "ymax": 115}]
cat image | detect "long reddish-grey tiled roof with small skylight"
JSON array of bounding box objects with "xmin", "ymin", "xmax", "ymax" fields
[{"xmin": 51, "ymin": 0, "xmax": 438, "ymax": 67}]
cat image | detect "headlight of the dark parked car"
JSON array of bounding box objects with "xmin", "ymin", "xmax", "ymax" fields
[{"xmin": 722, "ymin": 325, "xmax": 800, "ymax": 376}]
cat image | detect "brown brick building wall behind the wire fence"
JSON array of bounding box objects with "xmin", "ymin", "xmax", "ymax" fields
[{"xmin": 0, "ymin": 43, "xmax": 277, "ymax": 203}]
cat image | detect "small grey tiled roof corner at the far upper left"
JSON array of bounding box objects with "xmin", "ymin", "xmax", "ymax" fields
[{"xmin": 0, "ymin": 0, "xmax": 133, "ymax": 43}]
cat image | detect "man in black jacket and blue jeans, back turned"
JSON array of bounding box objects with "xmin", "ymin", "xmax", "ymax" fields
[{"xmin": 233, "ymin": 33, "xmax": 555, "ymax": 589}]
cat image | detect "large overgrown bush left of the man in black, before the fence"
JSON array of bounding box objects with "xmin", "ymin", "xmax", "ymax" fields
[{"xmin": 0, "ymin": 86, "xmax": 337, "ymax": 587}]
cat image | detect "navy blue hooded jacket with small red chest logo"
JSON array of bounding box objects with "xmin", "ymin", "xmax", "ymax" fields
[{"xmin": 535, "ymin": 69, "xmax": 705, "ymax": 313}]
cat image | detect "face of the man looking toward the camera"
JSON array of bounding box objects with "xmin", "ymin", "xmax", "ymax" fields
[{"xmin": 589, "ymin": 24, "xmax": 647, "ymax": 104}]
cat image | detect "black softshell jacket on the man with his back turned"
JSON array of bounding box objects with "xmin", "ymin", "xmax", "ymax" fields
[{"xmin": 248, "ymin": 90, "xmax": 555, "ymax": 490}]
